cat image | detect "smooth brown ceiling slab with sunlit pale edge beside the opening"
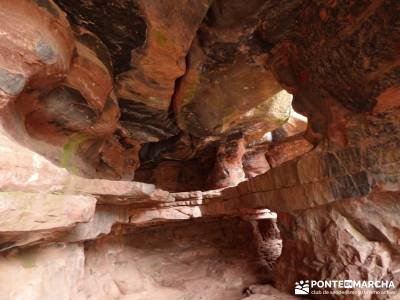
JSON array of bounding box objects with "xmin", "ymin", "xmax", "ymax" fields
[{"xmin": 174, "ymin": 33, "xmax": 292, "ymax": 140}]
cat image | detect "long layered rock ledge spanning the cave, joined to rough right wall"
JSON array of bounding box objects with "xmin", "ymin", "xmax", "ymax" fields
[{"xmin": 0, "ymin": 102, "xmax": 400, "ymax": 297}]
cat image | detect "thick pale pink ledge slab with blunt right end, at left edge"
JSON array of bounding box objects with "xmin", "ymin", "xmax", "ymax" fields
[{"xmin": 0, "ymin": 192, "xmax": 96, "ymax": 251}]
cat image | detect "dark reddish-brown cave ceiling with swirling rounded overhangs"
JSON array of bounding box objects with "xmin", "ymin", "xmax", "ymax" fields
[{"xmin": 0, "ymin": 0, "xmax": 400, "ymax": 183}]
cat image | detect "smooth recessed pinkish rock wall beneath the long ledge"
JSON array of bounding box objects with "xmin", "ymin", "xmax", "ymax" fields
[{"xmin": 0, "ymin": 219, "xmax": 262, "ymax": 300}]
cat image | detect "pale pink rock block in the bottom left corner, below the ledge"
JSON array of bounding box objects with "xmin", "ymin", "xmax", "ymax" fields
[{"xmin": 0, "ymin": 243, "xmax": 87, "ymax": 300}]
